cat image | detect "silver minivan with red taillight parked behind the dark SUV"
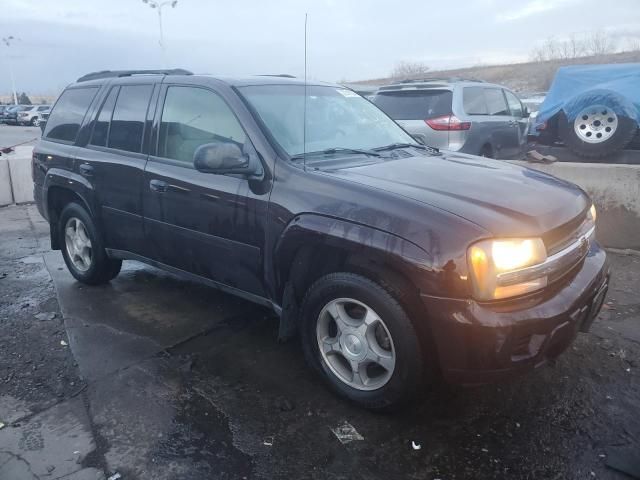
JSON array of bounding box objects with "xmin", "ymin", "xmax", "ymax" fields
[{"xmin": 373, "ymin": 78, "xmax": 529, "ymax": 159}]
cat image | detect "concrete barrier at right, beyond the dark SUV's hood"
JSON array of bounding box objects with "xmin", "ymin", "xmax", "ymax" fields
[{"xmin": 512, "ymin": 161, "xmax": 640, "ymax": 250}]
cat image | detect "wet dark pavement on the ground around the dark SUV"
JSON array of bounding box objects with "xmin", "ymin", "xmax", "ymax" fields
[{"xmin": 0, "ymin": 206, "xmax": 640, "ymax": 480}]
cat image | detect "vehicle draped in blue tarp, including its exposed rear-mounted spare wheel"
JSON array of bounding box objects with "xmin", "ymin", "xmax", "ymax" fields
[{"xmin": 535, "ymin": 63, "xmax": 640, "ymax": 158}]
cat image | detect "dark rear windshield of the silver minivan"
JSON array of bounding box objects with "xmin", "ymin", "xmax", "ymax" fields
[{"xmin": 373, "ymin": 90, "xmax": 453, "ymax": 120}]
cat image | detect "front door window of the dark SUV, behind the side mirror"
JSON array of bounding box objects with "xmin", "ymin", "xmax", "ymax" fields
[{"xmin": 158, "ymin": 87, "xmax": 246, "ymax": 163}]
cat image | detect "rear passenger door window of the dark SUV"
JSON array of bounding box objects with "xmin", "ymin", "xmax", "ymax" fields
[{"xmin": 107, "ymin": 85, "xmax": 153, "ymax": 152}]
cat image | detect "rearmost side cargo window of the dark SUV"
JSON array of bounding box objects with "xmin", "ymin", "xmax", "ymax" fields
[{"xmin": 44, "ymin": 87, "xmax": 98, "ymax": 142}]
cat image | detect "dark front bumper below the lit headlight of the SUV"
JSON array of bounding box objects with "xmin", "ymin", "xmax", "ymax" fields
[{"xmin": 422, "ymin": 243, "xmax": 609, "ymax": 385}]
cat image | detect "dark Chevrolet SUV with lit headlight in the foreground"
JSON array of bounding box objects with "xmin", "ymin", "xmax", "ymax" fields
[{"xmin": 33, "ymin": 71, "xmax": 608, "ymax": 409}]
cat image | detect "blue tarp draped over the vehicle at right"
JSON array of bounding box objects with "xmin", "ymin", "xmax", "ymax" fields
[{"xmin": 536, "ymin": 63, "xmax": 640, "ymax": 130}]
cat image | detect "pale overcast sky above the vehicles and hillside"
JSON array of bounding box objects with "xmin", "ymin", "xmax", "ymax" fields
[{"xmin": 0, "ymin": 0, "xmax": 640, "ymax": 94}]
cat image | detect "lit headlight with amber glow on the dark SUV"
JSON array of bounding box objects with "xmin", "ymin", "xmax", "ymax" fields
[{"xmin": 467, "ymin": 238, "xmax": 547, "ymax": 300}]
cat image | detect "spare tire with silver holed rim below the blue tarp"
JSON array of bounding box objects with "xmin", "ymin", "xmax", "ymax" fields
[{"xmin": 558, "ymin": 105, "xmax": 638, "ymax": 158}]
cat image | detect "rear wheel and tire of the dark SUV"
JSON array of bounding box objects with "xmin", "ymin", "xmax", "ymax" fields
[{"xmin": 57, "ymin": 202, "xmax": 122, "ymax": 285}]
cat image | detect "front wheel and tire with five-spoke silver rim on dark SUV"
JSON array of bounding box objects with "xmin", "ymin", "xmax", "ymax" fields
[{"xmin": 300, "ymin": 273, "xmax": 425, "ymax": 411}]
